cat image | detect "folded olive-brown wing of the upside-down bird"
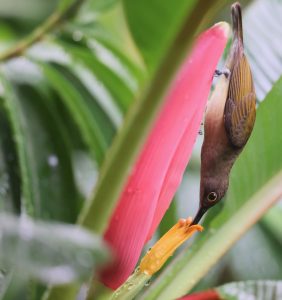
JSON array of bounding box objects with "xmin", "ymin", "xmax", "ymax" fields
[{"xmin": 224, "ymin": 54, "xmax": 256, "ymax": 148}]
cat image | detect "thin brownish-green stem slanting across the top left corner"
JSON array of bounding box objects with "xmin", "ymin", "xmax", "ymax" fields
[{"xmin": 0, "ymin": 0, "xmax": 85, "ymax": 62}]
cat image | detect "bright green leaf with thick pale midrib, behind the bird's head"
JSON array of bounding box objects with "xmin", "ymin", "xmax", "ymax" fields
[{"xmin": 142, "ymin": 78, "xmax": 282, "ymax": 299}]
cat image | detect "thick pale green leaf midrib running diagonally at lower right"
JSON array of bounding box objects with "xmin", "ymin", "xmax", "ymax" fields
[{"xmin": 141, "ymin": 171, "xmax": 282, "ymax": 300}]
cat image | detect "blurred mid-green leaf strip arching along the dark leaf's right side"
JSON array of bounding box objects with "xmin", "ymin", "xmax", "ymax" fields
[{"xmin": 42, "ymin": 64, "xmax": 114, "ymax": 164}]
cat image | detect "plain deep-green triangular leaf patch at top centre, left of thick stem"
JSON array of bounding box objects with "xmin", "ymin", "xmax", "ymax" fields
[{"xmin": 123, "ymin": 0, "xmax": 197, "ymax": 70}]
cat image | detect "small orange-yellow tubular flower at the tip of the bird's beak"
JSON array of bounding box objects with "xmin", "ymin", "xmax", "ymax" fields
[{"xmin": 140, "ymin": 218, "xmax": 203, "ymax": 275}]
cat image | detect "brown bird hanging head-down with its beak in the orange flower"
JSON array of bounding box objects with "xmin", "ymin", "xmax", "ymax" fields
[{"xmin": 191, "ymin": 2, "xmax": 256, "ymax": 225}]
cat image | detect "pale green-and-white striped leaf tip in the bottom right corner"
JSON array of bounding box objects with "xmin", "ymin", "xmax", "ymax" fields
[{"xmin": 216, "ymin": 280, "xmax": 282, "ymax": 300}]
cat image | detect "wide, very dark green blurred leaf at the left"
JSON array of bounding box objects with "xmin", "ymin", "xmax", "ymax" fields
[{"xmin": 3, "ymin": 73, "xmax": 80, "ymax": 222}]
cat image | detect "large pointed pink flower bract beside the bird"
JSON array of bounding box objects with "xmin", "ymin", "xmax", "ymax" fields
[{"xmin": 100, "ymin": 22, "xmax": 229, "ymax": 289}]
